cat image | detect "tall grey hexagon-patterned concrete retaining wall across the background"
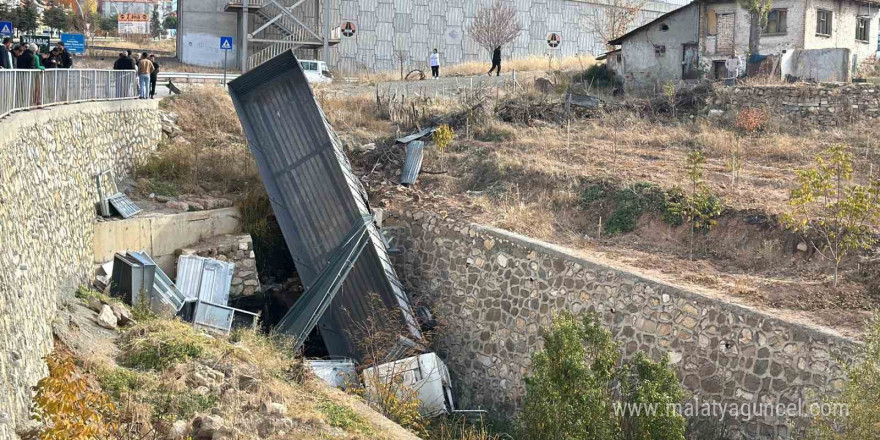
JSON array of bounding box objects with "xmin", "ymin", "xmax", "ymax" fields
[{"xmin": 179, "ymin": 0, "xmax": 687, "ymax": 72}]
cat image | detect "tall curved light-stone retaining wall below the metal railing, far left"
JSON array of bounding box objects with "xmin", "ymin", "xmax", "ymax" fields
[{"xmin": 0, "ymin": 101, "xmax": 161, "ymax": 440}]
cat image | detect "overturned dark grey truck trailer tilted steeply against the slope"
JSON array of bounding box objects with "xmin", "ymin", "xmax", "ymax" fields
[{"xmin": 229, "ymin": 51, "xmax": 421, "ymax": 357}]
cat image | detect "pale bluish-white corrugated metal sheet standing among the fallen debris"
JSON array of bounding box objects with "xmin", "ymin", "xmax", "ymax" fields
[{"xmin": 177, "ymin": 255, "xmax": 235, "ymax": 306}]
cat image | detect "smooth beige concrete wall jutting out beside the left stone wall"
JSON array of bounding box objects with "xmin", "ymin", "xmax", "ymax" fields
[{"xmin": 92, "ymin": 208, "xmax": 241, "ymax": 277}]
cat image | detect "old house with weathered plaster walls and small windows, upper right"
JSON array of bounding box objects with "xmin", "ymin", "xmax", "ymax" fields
[{"xmin": 612, "ymin": 0, "xmax": 880, "ymax": 90}]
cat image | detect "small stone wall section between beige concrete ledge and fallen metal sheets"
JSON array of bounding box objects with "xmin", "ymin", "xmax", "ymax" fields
[{"xmin": 178, "ymin": 234, "xmax": 262, "ymax": 296}]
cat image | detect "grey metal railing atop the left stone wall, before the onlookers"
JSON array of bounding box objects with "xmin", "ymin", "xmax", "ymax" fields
[{"xmin": 0, "ymin": 69, "xmax": 138, "ymax": 118}]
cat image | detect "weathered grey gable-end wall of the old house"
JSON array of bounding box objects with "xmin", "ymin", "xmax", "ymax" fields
[{"xmin": 621, "ymin": 3, "xmax": 700, "ymax": 91}]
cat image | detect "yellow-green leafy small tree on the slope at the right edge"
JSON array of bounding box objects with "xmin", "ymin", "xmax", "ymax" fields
[{"xmin": 783, "ymin": 145, "xmax": 880, "ymax": 287}]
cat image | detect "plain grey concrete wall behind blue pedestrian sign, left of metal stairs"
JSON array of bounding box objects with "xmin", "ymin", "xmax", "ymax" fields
[{"xmin": 177, "ymin": 0, "xmax": 241, "ymax": 69}]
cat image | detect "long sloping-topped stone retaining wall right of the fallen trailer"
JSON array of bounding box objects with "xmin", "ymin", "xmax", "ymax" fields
[{"xmin": 384, "ymin": 212, "xmax": 858, "ymax": 438}]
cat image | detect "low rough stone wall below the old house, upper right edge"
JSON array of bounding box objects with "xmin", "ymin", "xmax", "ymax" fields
[{"xmin": 707, "ymin": 84, "xmax": 880, "ymax": 126}]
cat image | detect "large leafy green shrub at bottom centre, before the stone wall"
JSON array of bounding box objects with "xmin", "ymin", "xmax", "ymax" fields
[{"xmin": 518, "ymin": 313, "xmax": 685, "ymax": 440}]
